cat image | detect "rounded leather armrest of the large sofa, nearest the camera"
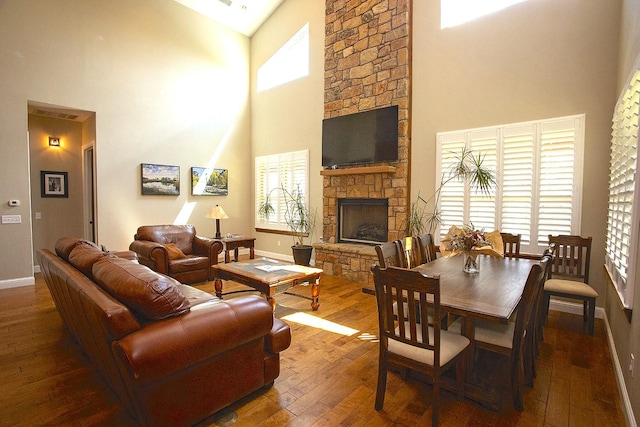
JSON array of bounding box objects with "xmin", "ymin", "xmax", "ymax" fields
[{"xmin": 113, "ymin": 295, "xmax": 273, "ymax": 386}]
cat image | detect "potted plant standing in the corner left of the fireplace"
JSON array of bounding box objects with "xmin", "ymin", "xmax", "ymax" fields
[{"xmin": 258, "ymin": 186, "xmax": 316, "ymax": 266}]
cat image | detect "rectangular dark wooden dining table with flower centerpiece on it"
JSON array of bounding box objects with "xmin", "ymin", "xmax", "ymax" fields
[{"xmin": 413, "ymin": 255, "xmax": 540, "ymax": 411}]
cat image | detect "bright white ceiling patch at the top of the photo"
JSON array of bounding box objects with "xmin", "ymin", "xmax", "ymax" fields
[{"xmin": 175, "ymin": 0, "xmax": 283, "ymax": 37}]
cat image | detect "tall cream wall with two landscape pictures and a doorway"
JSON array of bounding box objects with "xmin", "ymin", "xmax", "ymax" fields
[{"xmin": 0, "ymin": 0, "xmax": 253, "ymax": 281}]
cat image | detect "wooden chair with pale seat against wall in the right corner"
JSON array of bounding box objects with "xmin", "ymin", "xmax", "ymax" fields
[{"xmin": 543, "ymin": 235, "xmax": 598, "ymax": 335}]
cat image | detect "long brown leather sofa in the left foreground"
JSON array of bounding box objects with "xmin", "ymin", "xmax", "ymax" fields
[{"xmin": 37, "ymin": 238, "xmax": 291, "ymax": 426}]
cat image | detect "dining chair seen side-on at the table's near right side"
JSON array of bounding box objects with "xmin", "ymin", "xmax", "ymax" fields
[{"xmin": 449, "ymin": 258, "xmax": 548, "ymax": 411}]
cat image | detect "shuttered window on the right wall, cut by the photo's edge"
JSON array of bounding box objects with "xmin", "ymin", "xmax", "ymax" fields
[{"xmin": 605, "ymin": 64, "xmax": 640, "ymax": 309}]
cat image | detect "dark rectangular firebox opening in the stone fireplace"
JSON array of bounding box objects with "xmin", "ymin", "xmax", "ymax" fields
[{"xmin": 338, "ymin": 199, "xmax": 389, "ymax": 245}]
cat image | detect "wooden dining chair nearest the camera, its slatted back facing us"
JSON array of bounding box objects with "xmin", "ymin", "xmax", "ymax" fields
[{"xmin": 371, "ymin": 265, "xmax": 469, "ymax": 426}]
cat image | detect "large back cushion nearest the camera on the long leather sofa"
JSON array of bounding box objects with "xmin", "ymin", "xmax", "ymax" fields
[{"xmin": 92, "ymin": 258, "xmax": 189, "ymax": 320}]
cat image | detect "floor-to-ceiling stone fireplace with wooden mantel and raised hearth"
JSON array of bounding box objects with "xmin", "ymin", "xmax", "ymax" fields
[{"xmin": 314, "ymin": 0, "xmax": 411, "ymax": 284}]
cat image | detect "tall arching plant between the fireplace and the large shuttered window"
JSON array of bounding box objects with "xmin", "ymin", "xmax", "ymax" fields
[{"xmin": 406, "ymin": 148, "xmax": 496, "ymax": 236}]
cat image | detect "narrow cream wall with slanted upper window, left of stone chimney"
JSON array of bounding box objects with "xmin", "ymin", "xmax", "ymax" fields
[{"xmin": 251, "ymin": 0, "xmax": 324, "ymax": 257}]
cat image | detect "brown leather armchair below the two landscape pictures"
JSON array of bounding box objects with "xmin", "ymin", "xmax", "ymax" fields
[{"xmin": 129, "ymin": 225, "xmax": 223, "ymax": 283}]
